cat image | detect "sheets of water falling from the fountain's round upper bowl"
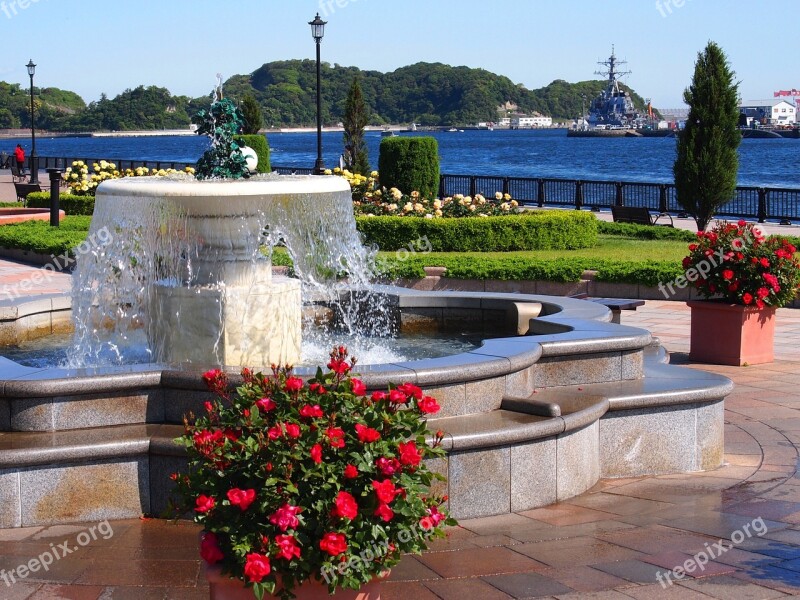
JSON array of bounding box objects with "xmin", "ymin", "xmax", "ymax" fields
[{"xmin": 66, "ymin": 175, "xmax": 404, "ymax": 367}]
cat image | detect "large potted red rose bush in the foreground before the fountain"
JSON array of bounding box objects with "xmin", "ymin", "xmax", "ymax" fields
[{"xmin": 173, "ymin": 347, "xmax": 455, "ymax": 599}]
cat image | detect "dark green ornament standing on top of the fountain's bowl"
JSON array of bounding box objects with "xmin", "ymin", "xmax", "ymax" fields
[{"xmin": 192, "ymin": 98, "xmax": 250, "ymax": 179}]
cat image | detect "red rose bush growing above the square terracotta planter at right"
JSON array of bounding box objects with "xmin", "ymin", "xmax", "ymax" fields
[{"xmin": 683, "ymin": 221, "xmax": 800, "ymax": 308}]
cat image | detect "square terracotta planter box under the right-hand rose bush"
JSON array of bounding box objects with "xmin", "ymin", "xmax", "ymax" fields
[{"xmin": 687, "ymin": 301, "xmax": 775, "ymax": 367}]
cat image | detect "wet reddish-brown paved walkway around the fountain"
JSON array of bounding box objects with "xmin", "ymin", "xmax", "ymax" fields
[{"xmin": 0, "ymin": 261, "xmax": 800, "ymax": 600}]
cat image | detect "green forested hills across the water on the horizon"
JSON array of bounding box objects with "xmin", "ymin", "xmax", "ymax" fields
[{"xmin": 0, "ymin": 60, "xmax": 644, "ymax": 131}]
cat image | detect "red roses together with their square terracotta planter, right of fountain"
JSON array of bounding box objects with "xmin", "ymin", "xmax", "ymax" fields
[{"xmin": 683, "ymin": 221, "xmax": 800, "ymax": 365}]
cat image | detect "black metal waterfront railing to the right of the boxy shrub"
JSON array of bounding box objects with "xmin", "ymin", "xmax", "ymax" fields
[{"xmin": 439, "ymin": 175, "xmax": 800, "ymax": 223}]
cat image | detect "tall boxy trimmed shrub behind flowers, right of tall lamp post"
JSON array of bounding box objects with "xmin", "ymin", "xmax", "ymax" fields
[{"xmin": 378, "ymin": 137, "xmax": 439, "ymax": 198}]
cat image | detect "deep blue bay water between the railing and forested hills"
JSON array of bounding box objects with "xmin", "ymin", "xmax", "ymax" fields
[{"xmin": 0, "ymin": 129, "xmax": 800, "ymax": 187}]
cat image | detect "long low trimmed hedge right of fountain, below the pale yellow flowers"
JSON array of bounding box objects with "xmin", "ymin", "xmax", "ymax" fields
[{"xmin": 356, "ymin": 211, "xmax": 597, "ymax": 252}]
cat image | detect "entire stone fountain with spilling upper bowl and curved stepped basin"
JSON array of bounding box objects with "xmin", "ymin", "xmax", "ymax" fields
[{"xmin": 0, "ymin": 92, "xmax": 732, "ymax": 528}]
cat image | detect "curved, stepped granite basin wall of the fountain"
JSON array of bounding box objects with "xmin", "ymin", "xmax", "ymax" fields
[{"xmin": 0, "ymin": 287, "xmax": 732, "ymax": 527}]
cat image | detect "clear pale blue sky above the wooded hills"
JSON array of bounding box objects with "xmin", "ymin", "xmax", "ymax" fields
[{"xmin": 0, "ymin": 0, "xmax": 788, "ymax": 108}]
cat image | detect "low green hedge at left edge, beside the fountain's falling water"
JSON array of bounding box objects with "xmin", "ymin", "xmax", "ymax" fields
[{"xmin": 0, "ymin": 216, "xmax": 91, "ymax": 255}]
